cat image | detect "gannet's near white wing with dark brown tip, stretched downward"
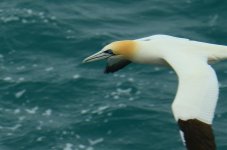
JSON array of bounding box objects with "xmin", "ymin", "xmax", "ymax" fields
[{"xmin": 165, "ymin": 52, "xmax": 218, "ymax": 150}]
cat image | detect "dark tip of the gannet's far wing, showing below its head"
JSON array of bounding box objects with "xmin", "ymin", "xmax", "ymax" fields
[{"xmin": 104, "ymin": 56, "xmax": 131, "ymax": 73}]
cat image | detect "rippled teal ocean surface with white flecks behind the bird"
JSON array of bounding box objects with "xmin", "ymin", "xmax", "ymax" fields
[{"xmin": 0, "ymin": 0, "xmax": 227, "ymax": 150}]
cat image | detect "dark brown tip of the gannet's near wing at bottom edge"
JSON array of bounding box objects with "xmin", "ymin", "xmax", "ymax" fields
[{"xmin": 178, "ymin": 119, "xmax": 216, "ymax": 150}]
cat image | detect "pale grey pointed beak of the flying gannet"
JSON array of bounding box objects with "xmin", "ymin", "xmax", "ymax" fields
[{"xmin": 83, "ymin": 52, "xmax": 112, "ymax": 63}]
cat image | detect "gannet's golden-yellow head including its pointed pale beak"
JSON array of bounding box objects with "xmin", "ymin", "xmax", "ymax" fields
[{"xmin": 83, "ymin": 40, "xmax": 138, "ymax": 63}]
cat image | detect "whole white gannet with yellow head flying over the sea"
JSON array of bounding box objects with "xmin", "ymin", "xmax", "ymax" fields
[{"xmin": 83, "ymin": 35, "xmax": 227, "ymax": 150}]
